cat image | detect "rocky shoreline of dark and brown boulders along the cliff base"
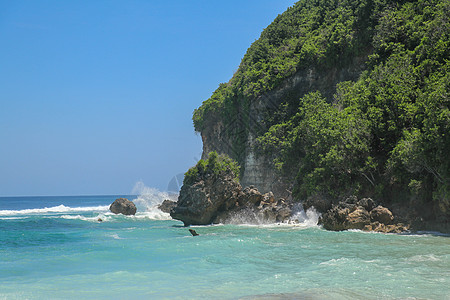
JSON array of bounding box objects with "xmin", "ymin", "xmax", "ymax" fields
[{"xmin": 164, "ymin": 158, "xmax": 418, "ymax": 233}]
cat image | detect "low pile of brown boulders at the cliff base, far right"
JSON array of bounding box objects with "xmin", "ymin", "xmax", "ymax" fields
[{"xmin": 319, "ymin": 197, "xmax": 409, "ymax": 233}]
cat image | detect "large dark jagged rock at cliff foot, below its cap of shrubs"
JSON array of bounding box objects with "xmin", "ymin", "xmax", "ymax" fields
[{"xmin": 170, "ymin": 175, "xmax": 292, "ymax": 226}]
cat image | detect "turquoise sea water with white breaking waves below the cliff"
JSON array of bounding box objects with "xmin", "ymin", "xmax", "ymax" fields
[{"xmin": 0, "ymin": 190, "xmax": 450, "ymax": 299}]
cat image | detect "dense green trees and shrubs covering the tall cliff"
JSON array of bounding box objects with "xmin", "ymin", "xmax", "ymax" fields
[{"xmin": 193, "ymin": 0, "xmax": 450, "ymax": 218}]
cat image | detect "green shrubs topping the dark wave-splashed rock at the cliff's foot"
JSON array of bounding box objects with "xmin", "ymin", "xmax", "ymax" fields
[{"xmin": 183, "ymin": 151, "xmax": 239, "ymax": 185}]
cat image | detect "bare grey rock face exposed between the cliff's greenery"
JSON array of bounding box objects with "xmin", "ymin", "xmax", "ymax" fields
[{"xmin": 201, "ymin": 55, "xmax": 367, "ymax": 198}]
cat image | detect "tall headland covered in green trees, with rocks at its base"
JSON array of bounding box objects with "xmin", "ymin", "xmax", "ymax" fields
[{"xmin": 185, "ymin": 0, "xmax": 450, "ymax": 232}]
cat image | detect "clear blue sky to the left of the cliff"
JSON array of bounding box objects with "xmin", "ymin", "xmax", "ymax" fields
[{"xmin": 0, "ymin": 0, "xmax": 295, "ymax": 196}]
